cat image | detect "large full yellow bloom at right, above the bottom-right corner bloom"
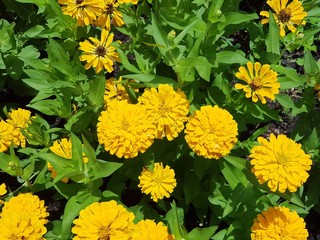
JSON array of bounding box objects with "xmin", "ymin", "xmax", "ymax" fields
[{"xmin": 249, "ymin": 134, "xmax": 312, "ymax": 193}]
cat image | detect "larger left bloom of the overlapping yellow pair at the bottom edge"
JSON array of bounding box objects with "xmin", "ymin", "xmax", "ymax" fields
[{"xmin": 71, "ymin": 200, "xmax": 134, "ymax": 240}]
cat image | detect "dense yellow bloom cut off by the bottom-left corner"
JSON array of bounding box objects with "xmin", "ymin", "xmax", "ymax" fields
[{"xmin": 0, "ymin": 193, "xmax": 49, "ymax": 240}]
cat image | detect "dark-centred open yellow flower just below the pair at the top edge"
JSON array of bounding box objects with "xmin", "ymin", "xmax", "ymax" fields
[{"xmin": 79, "ymin": 29, "xmax": 120, "ymax": 73}]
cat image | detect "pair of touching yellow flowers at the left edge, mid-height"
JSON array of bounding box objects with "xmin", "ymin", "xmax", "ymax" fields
[{"xmin": 0, "ymin": 108, "xmax": 31, "ymax": 152}]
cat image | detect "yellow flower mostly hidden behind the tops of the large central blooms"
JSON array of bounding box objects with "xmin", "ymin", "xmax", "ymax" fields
[{"xmin": 103, "ymin": 76, "xmax": 131, "ymax": 108}]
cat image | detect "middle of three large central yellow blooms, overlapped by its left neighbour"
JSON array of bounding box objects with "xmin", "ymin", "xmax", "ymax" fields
[{"xmin": 138, "ymin": 84, "xmax": 190, "ymax": 141}]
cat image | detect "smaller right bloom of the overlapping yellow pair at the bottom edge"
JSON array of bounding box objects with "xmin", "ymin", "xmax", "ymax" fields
[{"xmin": 131, "ymin": 219, "xmax": 174, "ymax": 240}]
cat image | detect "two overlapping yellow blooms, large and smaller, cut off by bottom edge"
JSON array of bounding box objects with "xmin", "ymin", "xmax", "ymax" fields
[{"xmin": 71, "ymin": 200, "xmax": 174, "ymax": 240}]
